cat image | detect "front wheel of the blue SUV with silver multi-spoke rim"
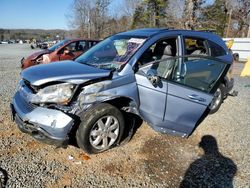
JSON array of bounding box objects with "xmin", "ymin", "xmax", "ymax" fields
[{"xmin": 76, "ymin": 103, "xmax": 124, "ymax": 154}]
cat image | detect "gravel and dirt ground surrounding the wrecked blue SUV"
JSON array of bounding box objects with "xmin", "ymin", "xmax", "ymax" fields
[{"xmin": 0, "ymin": 44, "xmax": 250, "ymax": 187}]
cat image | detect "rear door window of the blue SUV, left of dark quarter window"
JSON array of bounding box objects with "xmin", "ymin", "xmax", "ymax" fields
[{"xmin": 184, "ymin": 37, "xmax": 209, "ymax": 55}]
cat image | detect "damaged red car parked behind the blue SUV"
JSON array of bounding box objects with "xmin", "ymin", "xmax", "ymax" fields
[{"xmin": 21, "ymin": 39, "xmax": 99, "ymax": 69}]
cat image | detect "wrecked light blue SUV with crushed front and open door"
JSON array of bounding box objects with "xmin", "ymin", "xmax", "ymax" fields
[{"xmin": 11, "ymin": 29, "xmax": 233, "ymax": 153}]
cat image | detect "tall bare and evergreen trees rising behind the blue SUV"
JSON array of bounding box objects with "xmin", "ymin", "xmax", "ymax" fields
[{"xmin": 67, "ymin": 0, "xmax": 250, "ymax": 38}]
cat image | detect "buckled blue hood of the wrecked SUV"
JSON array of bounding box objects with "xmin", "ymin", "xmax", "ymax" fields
[{"xmin": 21, "ymin": 61, "xmax": 111, "ymax": 86}]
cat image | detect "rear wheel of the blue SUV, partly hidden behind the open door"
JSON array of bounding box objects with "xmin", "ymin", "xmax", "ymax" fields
[{"xmin": 209, "ymin": 84, "xmax": 225, "ymax": 114}]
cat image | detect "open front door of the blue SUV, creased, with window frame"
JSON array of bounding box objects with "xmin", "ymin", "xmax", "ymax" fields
[{"xmin": 136, "ymin": 56, "xmax": 229, "ymax": 136}]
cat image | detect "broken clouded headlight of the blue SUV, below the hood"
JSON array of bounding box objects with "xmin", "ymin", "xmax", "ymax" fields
[{"xmin": 30, "ymin": 83, "xmax": 75, "ymax": 104}]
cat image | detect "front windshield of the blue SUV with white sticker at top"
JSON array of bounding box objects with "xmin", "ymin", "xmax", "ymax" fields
[{"xmin": 75, "ymin": 35, "xmax": 146, "ymax": 70}]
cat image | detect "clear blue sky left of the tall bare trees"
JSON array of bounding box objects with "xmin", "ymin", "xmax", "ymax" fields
[{"xmin": 0, "ymin": 0, "xmax": 73, "ymax": 29}]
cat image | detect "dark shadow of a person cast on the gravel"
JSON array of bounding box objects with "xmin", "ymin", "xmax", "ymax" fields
[{"xmin": 180, "ymin": 135, "xmax": 237, "ymax": 188}]
